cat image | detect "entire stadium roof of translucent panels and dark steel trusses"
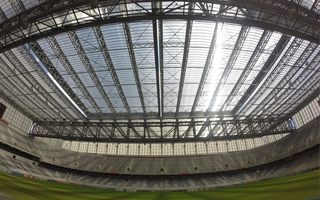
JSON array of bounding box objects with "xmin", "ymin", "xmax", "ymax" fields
[{"xmin": 0, "ymin": 0, "xmax": 320, "ymax": 142}]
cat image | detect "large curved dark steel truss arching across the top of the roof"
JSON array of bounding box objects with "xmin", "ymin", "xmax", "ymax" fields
[{"xmin": 0, "ymin": 0, "xmax": 320, "ymax": 52}]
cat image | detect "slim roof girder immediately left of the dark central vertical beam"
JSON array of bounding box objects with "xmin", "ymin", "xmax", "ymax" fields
[{"xmin": 123, "ymin": 23, "xmax": 146, "ymax": 113}]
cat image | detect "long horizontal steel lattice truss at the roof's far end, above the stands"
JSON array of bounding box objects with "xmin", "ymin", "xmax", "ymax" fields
[{"xmin": 29, "ymin": 118, "xmax": 294, "ymax": 143}]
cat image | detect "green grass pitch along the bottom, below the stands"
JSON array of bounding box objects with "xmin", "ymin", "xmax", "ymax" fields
[{"xmin": 0, "ymin": 170, "xmax": 320, "ymax": 200}]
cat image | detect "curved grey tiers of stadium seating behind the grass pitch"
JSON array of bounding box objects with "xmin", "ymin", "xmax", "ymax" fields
[{"xmin": 0, "ymin": 118, "xmax": 320, "ymax": 190}]
